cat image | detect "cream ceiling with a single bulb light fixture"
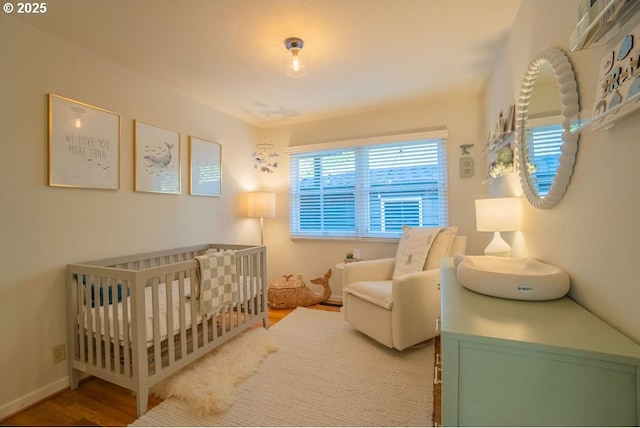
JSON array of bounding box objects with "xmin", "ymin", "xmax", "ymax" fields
[{"xmin": 14, "ymin": 0, "xmax": 520, "ymax": 127}]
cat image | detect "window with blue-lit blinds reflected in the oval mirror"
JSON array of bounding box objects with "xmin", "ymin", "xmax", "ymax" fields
[{"xmin": 527, "ymin": 119, "xmax": 564, "ymax": 196}]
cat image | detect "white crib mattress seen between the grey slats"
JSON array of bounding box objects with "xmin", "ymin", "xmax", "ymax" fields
[{"xmin": 82, "ymin": 277, "xmax": 260, "ymax": 345}]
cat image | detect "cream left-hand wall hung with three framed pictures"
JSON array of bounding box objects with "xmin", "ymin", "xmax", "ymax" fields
[{"xmin": 0, "ymin": 14, "xmax": 260, "ymax": 418}]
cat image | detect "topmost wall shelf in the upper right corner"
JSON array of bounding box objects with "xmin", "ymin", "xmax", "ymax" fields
[{"xmin": 569, "ymin": 0, "xmax": 640, "ymax": 51}]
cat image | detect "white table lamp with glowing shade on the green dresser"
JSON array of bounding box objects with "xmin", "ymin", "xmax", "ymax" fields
[{"xmin": 476, "ymin": 198, "xmax": 522, "ymax": 257}]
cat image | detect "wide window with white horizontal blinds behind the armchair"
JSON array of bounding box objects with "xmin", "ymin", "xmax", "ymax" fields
[{"xmin": 289, "ymin": 132, "xmax": 448, "ymax": 238}]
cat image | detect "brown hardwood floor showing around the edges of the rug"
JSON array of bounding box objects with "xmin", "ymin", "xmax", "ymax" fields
[{"xmin": 0, "ymin": 305, "xmax": 340, "ymax": 426}]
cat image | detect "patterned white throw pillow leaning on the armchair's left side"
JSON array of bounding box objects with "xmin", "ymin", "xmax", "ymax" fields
[{"xmin": 393, "ymin": 226, "xmax": 442, "ymax": 278}]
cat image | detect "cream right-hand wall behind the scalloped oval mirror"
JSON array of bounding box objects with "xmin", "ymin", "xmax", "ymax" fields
[{"xmin": 486, "ymin": 0, "xmax": 640, "ymax": 342}]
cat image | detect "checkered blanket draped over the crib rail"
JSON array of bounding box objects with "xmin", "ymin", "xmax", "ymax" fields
[{"xmin": 195, "ymin": 250, "xmax": 238, "ymax": 315}]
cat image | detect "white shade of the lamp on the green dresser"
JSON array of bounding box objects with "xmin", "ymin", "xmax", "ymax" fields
[{"xmin": 476, "ymin": 198, "xmax": 522, "ymax": 232}]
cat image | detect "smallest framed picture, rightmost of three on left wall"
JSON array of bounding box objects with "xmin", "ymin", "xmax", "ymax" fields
[{"xmin": 189, "ymin": 136, "xmax": 222, "ymax": 197}]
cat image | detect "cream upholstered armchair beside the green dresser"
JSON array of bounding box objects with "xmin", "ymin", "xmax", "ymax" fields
[{"xmin": 342, "ymin": 226, "xmax": 467, "ymax": 350}]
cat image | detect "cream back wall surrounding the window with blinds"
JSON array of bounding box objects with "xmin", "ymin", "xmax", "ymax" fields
[{"xmin": 263, "ymin": 94, "xmax": 490, "ymax": 298}]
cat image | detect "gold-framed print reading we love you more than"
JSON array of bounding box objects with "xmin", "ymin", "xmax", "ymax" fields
[{"xmin": 48, "ymin": 94, "xmax": 120, "ymax": 190}]
